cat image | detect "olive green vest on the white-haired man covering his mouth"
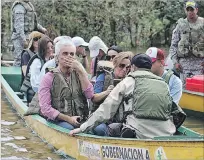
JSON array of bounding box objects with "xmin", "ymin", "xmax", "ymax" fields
[{"xmin": 51, "ymin": 68, "xmax": 89, "ymax": 119}]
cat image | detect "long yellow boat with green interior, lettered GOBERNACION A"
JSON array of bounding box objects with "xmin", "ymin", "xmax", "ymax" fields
[{"xmin": 1, "ymin": 67, "xmax": 204, "ymax": 160}]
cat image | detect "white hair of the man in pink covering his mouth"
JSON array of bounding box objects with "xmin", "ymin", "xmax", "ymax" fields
[{"xmin": 55, "ymin": 36, "xmax": 76, "ymax": 55}]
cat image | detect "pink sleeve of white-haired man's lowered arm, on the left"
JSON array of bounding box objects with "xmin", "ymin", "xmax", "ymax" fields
[{"xmin": 38, "ymin": 72, "xmax": 60, "ymax": 120}]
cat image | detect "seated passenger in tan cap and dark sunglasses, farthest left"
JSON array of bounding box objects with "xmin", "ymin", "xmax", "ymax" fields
[{"xmin": 21, "ymin": 31, "xmax": 43, "ymax": 79}]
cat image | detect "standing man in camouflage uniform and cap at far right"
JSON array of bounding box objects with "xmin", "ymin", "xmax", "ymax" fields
[{"xmin": 169, "ymin": 0, "xmax": 204, "ymax": 86}]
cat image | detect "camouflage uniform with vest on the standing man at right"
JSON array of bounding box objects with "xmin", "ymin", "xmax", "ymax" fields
[{"xmin": 169, "ymin": 17, "xmax": 204, "ymax": 86}]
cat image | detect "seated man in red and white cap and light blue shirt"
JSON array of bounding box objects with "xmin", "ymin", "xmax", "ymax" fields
[{"xmin": 146, "ymin": 47, "xmax": 182, "ymax": 104}]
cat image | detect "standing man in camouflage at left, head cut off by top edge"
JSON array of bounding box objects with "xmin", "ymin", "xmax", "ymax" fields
[{"xmin": 11, "ymin": 0, "xmax": 47, "ymax": 66}]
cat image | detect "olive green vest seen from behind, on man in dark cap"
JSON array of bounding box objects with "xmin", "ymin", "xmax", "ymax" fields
[{"xmin": 129, "ymin": 69, "xmax": 172, "ymax": 120}]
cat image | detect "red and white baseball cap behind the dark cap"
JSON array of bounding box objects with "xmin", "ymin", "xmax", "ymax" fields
[{"xmin": 145, "ymin": 47, "xmax": 164, "ymax": 65}]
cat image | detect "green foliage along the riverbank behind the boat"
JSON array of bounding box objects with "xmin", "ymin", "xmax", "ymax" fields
[{"xmin": 1, "ymin": 0, "xmax": 204, "ymax": 48}]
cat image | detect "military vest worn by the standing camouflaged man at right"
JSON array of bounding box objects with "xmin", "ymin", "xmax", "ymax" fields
[{"xmin": 177, "ymin": 17, "xmax": 204, "ymax": 57}]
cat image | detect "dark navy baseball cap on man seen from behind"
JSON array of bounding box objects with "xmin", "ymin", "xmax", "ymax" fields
[{"xmin": 131, "ymin": 53, "xmax": 152, "ymax": 69}]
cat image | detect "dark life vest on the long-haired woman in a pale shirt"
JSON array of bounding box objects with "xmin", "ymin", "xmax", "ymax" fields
[{"xmin": 20, "ymin": 54, "xmax": 45, "ymax": 103}]
